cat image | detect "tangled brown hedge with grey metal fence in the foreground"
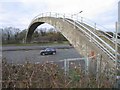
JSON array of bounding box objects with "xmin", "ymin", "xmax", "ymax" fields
[{"xmin": 2, "ymin": 56, "xmax": 115, "ymax": 88}]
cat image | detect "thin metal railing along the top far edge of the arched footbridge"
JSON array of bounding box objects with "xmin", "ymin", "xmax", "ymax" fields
[{"xmin": 32, "ymin": 12, "xmax": 120, "ymax": 46}]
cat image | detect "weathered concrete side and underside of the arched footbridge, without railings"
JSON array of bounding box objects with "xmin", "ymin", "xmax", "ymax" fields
[{"xmin": 26, "ymin": 17, "xmax": 113, "ymax": 68}]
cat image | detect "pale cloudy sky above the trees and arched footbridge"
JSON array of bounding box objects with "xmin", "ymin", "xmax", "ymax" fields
[{"xmin": 0, "ymin": 0, "xmax": 119, "ymax": 31}]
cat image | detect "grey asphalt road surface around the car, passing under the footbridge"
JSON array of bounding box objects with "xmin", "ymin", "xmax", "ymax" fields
[{"xmin": 2, "ymin": 47, "xmax": 81, "ymax": 64}]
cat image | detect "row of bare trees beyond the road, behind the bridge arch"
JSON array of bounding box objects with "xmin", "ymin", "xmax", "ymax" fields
[{"xmin": 1, "ymin": 27, "xmax": 67, "ymax": 44}]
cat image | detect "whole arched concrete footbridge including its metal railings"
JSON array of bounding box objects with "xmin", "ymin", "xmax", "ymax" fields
[{"xmin": 26, "ymin": 12, "xmax": 120, "ymax": 67}]
